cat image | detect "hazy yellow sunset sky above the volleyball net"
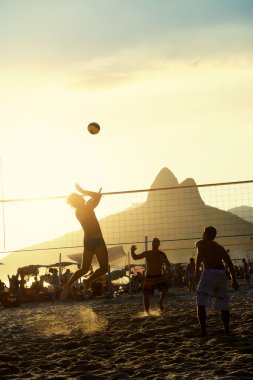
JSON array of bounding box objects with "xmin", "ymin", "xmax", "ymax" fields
[{"xmin": 0, "ymin": 0, "xmax": 253, "ymax": 255}]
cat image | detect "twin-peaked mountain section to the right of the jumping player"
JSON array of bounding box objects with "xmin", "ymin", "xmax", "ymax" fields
[{"xmin": 100, "ymin": 168, "xmax": 253, "ymax": 261}]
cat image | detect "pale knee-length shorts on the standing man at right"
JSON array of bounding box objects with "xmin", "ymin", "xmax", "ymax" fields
[{"xmin": 197, "ymin": 269, "xmax": 229, "ymax": 310}]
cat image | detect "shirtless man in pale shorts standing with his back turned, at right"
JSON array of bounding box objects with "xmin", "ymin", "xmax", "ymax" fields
[{"xmin": 195, "ymin": 226, "xmax": 238, "ymax": 336}]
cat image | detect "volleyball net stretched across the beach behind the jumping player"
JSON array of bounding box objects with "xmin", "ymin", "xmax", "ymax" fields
[{"xmin": 0, "ymin": 180, "xmax": 253, "ymax": 261}]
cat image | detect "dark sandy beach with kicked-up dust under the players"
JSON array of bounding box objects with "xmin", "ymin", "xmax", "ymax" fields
[{"xmin": 0, "ymin": 285, "xmax": 253, "ymax": 380}]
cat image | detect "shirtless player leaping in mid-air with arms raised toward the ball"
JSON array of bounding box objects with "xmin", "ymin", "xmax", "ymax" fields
[{"xmin": 61, "ymin": 184, "xmax": 108, "ymax": 301}]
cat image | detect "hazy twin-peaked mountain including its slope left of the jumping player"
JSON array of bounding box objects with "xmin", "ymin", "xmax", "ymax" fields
[{"xmin": 0, "ymin": 168, "xmax": 253, "ymax": 278}]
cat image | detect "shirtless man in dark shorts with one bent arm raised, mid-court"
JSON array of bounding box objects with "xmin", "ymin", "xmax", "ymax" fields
[{"xmin": 131, "ymin": 238, "xmax": 170, "ymax": 314}]
